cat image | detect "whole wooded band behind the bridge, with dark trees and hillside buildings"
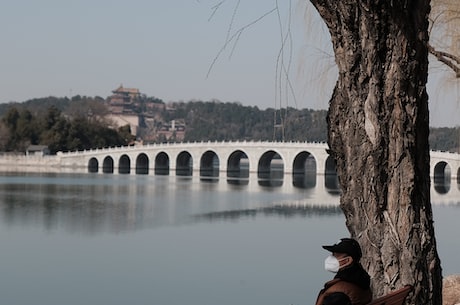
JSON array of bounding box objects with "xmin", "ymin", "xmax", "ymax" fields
[{"xmin": 0, "ymin": 93, "xmax": 460, "ymax": 154}]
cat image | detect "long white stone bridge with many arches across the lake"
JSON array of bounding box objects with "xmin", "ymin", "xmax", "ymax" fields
[{"xmin": 0, "ymin": 141, "xmax": 460, "ymax": 182}]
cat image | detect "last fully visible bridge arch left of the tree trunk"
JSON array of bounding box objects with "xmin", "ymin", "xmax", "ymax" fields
[{"xmin": 292, "ymin": 151, "xmax": 317, "ymax": 188}]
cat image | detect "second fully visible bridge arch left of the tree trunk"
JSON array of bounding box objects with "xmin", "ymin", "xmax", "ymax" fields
[{"xmin": 257, "ymin": 150, "xmax": 284, "ymax": 186}]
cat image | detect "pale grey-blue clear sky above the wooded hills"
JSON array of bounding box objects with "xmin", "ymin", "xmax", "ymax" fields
[{"xmin": 0, "ymin": 0, "xmax": 460, "ymax": 127}]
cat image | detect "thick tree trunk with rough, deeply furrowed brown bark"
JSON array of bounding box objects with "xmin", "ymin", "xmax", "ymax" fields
[{"xmin": 310, "ymin": 0, "xmax": 442, "ymax": 304}]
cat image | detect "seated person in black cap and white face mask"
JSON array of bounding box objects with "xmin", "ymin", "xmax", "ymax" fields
[{"xmin": 316, "ymin": 238, "xmax": 372, "ymax": 305}]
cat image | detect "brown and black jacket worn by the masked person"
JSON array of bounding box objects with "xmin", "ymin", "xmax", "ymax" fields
[{"xmin": 316, "ymin": 263, "xmax": 372, "ymax": 305}]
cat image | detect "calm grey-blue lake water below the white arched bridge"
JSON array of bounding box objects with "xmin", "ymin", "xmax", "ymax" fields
[{"xmin": 0, "ymin": 174, "xmax": 460, "ymax": 305}]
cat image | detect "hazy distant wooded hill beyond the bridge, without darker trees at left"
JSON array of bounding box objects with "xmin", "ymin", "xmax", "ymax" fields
[{"xmin": 0, "ymin": 95, "xmax": 460, "ymax": 152}]
